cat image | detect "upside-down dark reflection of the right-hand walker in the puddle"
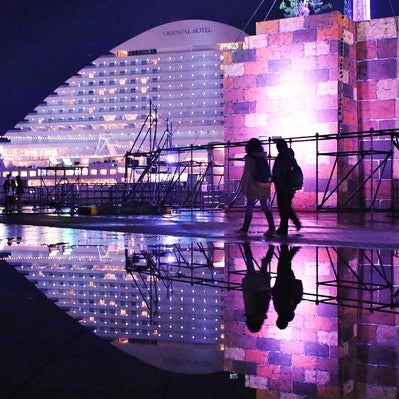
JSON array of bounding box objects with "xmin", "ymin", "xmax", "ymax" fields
[{"xmin": 272, "ymin": 245, "xmax": 303, "ymax": 330}]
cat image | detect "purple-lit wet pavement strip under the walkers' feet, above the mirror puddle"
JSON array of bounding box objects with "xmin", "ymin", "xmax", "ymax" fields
[{"xmin": 3, "ymin": 210, "xmax": 399, "ymax": 248}]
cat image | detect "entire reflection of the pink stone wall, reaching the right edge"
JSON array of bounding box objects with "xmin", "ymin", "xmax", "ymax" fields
[{"xmin": 224, "ymin": 245, "xmax": 399, "ymax": 399}]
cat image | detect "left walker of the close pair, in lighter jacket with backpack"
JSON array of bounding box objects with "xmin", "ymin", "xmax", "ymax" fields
[{"xmin": 235, "ymin": 138, "xmax": 276, "ymax": 236}]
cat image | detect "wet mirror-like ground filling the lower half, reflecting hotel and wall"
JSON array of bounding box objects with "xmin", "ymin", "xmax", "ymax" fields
[{"xmin": 0, "ymin": 211, "xmax": 399, "ymax": 399}]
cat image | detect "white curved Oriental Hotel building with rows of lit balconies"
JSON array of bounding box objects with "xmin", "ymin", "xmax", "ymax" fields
[{"xmin": 0, "ymin": 20, "xmax": 245, "ymax": 170}]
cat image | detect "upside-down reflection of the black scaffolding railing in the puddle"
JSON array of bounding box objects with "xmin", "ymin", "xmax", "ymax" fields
[{"xmin": 126, "ymin": 242, "xmax": 399, "ymax": 314}]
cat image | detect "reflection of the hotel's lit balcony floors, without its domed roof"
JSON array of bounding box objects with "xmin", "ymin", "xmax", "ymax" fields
[{"xmin": 10, "ymin": 239, "xmax": 223, "ymax": 343}]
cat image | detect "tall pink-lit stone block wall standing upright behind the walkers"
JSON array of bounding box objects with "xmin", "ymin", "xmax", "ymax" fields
[{"xmin": 224, "ymin": 12, "xmax": 399, "ymax": 208}]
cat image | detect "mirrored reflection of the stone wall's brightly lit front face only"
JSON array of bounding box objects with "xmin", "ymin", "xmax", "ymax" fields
[{"xmin": 225, "ymin": 247, "xmax": 339, "ymax": 399}]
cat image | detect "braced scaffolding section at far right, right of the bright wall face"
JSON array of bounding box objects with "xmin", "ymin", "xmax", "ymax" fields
[{"xmin": 315, "ymin": 129, "xmax": 399, "ymax": 211}]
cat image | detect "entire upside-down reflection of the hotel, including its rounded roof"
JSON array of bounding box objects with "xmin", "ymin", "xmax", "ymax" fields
[{"xmin": 4, "ymin": 239, "xmax": 228, "ymax": 372}]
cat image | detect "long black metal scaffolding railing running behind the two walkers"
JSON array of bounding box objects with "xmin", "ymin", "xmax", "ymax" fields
[{"xmin": 14, "ymin": 129, "xmax": 399, "ymax": 215}]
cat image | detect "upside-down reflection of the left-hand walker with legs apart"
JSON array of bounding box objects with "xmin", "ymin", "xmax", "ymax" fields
[{"xmin": 242, "ymin": 242, "xmax": 274, "ymax": 332}]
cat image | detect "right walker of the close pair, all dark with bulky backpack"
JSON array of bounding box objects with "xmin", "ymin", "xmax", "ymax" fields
[{"xmin": 273, "ymin": 139, "xmax": 302, "ymax": 237}]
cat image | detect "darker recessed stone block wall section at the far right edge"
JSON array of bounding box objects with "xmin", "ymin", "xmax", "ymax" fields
[{"xmin": 356, "ymin": 17, "xmax": 399, "ymax": 208}]
